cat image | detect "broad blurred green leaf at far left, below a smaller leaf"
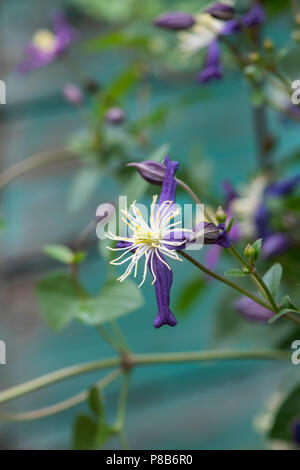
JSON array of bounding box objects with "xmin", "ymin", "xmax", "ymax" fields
[{"xmin": 37, "ymin": 273, "xmax": 80, "ymax": 330}]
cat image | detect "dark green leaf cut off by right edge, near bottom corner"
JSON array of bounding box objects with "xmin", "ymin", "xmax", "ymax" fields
[{"xmin": 269, "ymin": 385, "xmax": 300, "ymax": 441}]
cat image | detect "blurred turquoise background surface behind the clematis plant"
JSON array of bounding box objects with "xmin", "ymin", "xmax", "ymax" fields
[{"xmin": 0, "ymin": 0, "xmax": 300, "ymax": 449}]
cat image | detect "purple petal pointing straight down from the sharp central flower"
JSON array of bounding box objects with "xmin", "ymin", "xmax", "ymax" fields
[{"xmin": 152, "ymin": 255, "xmax": 177, "ymax": 328}]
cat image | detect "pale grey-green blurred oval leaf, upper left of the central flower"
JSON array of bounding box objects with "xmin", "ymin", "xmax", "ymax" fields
[{"xmin": 68, "ymin": 166, "xmax": 102, "ymax": 212}]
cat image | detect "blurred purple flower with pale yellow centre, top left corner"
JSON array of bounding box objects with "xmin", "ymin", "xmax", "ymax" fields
[{"xmin": 18, "ymin": 12, "xmax": 77, "ymax": 73}]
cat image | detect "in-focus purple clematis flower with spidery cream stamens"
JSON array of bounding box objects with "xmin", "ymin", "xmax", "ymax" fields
[{"xmin": 107, "ymin": 156, "xmax": 230, "ymax": 328}]
